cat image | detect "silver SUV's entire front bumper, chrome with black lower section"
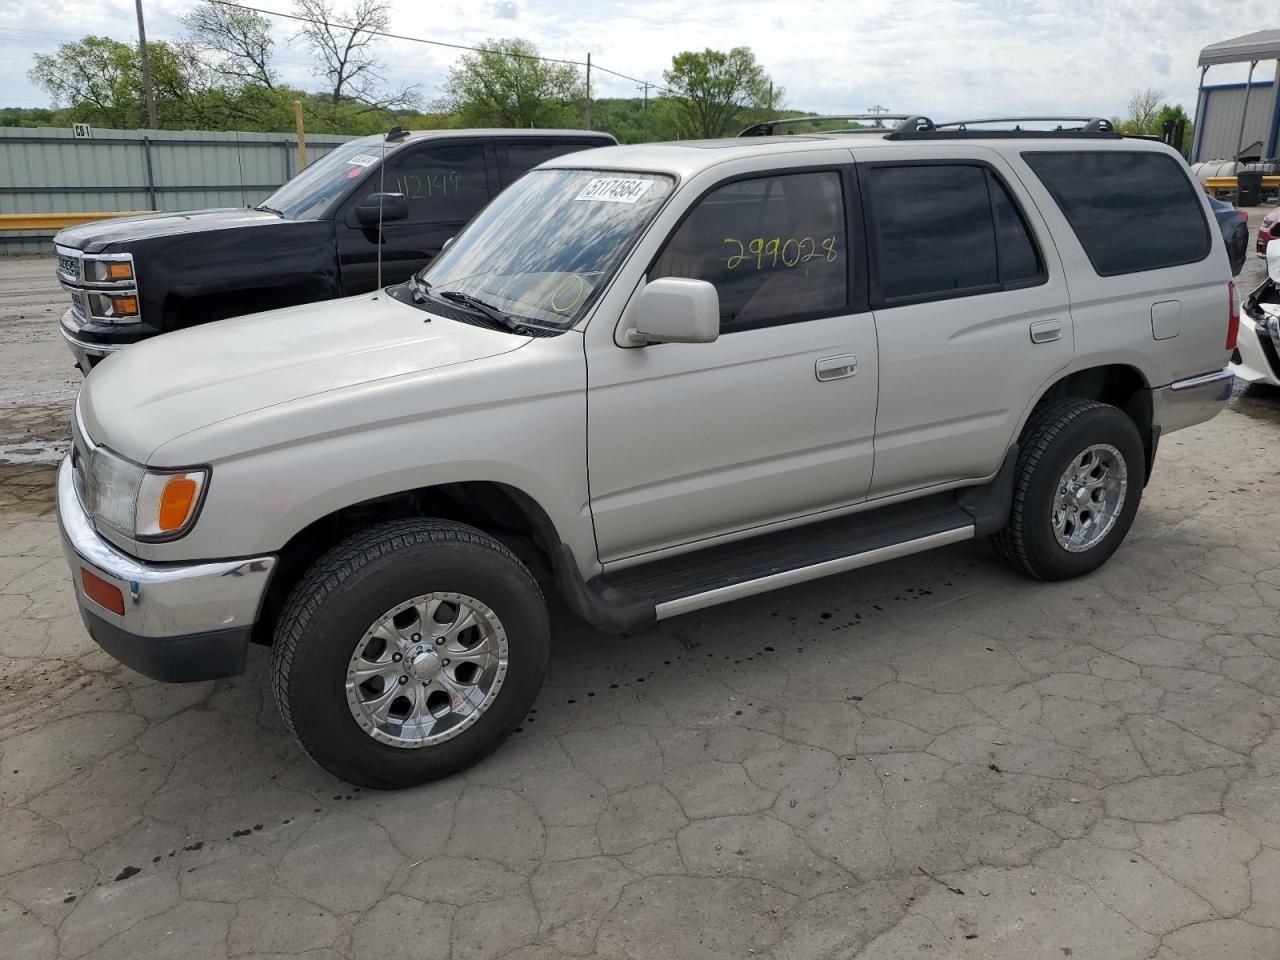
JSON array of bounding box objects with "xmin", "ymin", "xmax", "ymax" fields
[{"xmin": 58, "ymin": 457, "xmax": 275, "ymax": 682}]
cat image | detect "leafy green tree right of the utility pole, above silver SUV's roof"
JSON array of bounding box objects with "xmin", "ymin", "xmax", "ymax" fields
[{"xmin": 662, "ymin": 46, "xmax": 782, "ymax": 137}]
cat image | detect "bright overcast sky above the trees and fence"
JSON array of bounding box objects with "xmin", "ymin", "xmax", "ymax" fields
[{"xmin": 0, "ymin": 0, "xmax": 1280, "ymax": 118}]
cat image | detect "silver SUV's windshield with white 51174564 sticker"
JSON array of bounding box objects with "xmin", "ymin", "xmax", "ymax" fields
[{"xmin": 420, "ymin": 169, "xmax": 675, "ymax": 328}]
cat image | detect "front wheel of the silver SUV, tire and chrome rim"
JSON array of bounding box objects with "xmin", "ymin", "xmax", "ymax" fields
[{"xmin": 271, "ymin": 520, "xmax": 550, "ymax": 788}]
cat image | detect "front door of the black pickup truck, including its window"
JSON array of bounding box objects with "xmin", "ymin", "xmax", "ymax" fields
[{"xmin": 335, "ymin": 140, "xmax": 497, "ymax": 296}]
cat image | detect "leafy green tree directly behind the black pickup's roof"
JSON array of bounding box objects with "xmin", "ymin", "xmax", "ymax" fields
[{"xmin": 438, "ymin": 38, "xmax": 585, "ymax": 127}]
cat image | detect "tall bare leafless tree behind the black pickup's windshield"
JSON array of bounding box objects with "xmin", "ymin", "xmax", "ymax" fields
[{"xmin": 293, "ymin": 0, "xmax": 417, "ymax": 110}]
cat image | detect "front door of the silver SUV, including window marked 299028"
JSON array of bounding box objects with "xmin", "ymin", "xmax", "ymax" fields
[{"xmin": 588, "ymin": 165, "xmax": 877, "ymax": 563}]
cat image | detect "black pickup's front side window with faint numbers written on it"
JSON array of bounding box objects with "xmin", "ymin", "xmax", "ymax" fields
[{"xmin": 365, "ymin": 143, "xmax": 489, "ymax": 223}]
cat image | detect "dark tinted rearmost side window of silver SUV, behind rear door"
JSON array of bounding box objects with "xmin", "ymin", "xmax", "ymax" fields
[{"xmin": 1023, "ymin": 150, "xmax": 1211, "ymax": 276}]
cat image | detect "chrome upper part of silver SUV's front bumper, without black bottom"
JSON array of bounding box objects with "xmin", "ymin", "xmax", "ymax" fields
[{"xmin": 58, "ymin": 457, "xmax": 275, "ymax": 647}]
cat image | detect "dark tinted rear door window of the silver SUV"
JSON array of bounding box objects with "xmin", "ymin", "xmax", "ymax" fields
[{"xmin": 865, "ymin": 164, "xmax": 1044, "ymax": 303}]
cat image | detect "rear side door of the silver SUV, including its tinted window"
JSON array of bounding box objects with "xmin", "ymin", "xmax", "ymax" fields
[{"xmin": 858, "ymin": 152, "xmax": 1074, "ymax": 497}]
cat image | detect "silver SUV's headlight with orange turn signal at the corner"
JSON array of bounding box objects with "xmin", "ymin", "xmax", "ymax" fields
[{"xmin": 82, "ymin": 447, "xmax": 209, "ymax": 540}]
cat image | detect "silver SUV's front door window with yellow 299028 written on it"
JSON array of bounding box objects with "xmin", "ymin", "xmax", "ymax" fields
[{"xmin": 649, "ymin": 170, "xmax": 849, "ymax": 333}]
